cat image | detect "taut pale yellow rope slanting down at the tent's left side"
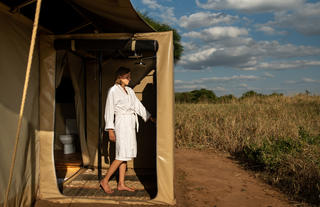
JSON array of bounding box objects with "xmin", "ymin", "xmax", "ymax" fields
[{"xmin": 4, "ymin": 0, "xmax": 42, "ymax": 207}]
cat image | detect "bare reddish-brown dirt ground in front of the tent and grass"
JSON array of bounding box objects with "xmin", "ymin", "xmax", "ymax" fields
[{"xmin": 35, "ymin": 149, "xmax": 307, "ymax": 207}]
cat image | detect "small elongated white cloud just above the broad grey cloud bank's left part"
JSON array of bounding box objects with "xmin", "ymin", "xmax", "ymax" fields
[{"xmin": 183, "ymin": 27, "xmax": 248, "ymax": 41}]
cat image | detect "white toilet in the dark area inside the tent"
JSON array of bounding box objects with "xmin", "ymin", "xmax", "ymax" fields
[{"xmin": 59, "ymin": 119, "xmax": 78, "ymax": 154}]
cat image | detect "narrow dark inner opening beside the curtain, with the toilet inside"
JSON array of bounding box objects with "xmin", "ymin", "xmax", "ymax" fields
[{"xmin": 54, "ymin": 69, "xmax": 83, "ymax": 190}]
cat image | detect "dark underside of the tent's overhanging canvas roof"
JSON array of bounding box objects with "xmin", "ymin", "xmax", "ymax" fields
[{"xmin": 0, "ymin": 0, "xmax": 154, "ymax": 34}]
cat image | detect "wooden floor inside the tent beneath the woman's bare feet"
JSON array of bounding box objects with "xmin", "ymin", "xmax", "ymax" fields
[{"xmin": 55, "ymin": 151, "xmax": 157, "ymax": 201}]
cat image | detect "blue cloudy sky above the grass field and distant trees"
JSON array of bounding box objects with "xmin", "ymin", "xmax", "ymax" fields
[{"xmin": 131, "ymin": 0, "xmax": 320, "ymax": 96}]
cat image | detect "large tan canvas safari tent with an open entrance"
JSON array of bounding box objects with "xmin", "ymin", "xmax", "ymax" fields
[{"xmin": 0, "ymin": 0, "xmax": 175, "ymax": 206}]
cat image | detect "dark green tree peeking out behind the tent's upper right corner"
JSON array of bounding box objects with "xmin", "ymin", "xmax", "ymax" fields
[{"xmin": 138, "ymin": 12, "xmax": 183, "ymax": 63}]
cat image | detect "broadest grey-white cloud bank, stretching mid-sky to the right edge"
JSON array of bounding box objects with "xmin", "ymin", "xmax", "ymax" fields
[{"xmin": 178, "ymin": 37, "xmax": 320, "ymax": 71}]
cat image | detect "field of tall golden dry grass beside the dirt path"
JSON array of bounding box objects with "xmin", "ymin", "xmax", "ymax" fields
[{"xmin": 175, "ymin": 94, "xmax": 320, "ymax": 203}]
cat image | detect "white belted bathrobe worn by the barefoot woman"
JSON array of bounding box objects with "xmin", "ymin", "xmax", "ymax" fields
[{"xmin": 104, "ymin": 84, "xmax": 150, "ymax": 161}]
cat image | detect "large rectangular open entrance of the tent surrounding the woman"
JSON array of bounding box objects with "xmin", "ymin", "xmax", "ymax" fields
[{"xmin": 54, "ymin": 39, "xmax": 158, "ymax": 200}]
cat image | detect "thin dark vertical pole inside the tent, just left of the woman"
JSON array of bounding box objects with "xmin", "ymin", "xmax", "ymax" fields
[{"xmin": 98, "ymin": 52, "xmax": 103, "ymax": 180}]
